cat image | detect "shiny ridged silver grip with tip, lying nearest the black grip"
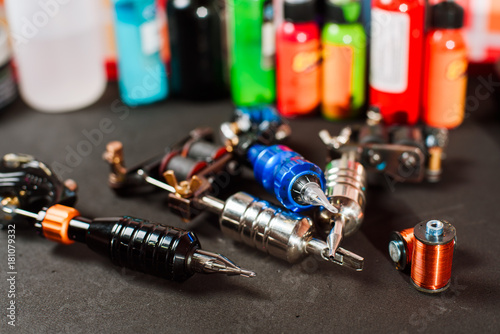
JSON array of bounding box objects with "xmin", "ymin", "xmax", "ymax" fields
[{"xmin": 197, "ymin": 192, "xmax": 364, "ymax": 271}]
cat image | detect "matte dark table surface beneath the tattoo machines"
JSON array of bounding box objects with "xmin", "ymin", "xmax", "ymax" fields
[{"xmin": 0, "ymin": 79, "xmax": 500, "ymax": 333}]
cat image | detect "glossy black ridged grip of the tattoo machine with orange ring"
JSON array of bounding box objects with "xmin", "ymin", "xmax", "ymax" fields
[{"xmin": 86, "ymin": 217, "xmax": 200, "ymax": 282}]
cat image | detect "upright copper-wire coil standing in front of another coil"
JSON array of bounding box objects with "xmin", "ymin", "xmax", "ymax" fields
[{"xmin": 411, "ymin": 221, "xmax": 455, "ymax": 293}]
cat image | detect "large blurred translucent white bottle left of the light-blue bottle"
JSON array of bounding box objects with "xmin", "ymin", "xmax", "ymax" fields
[{"xmin": 5, "ymin": 0, "xmax": 106, "ymax": 112}]
